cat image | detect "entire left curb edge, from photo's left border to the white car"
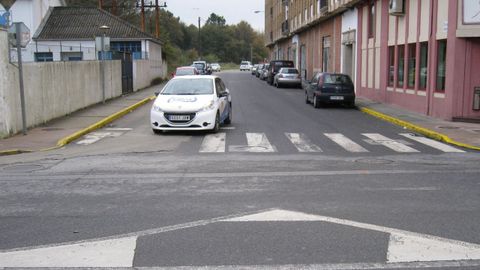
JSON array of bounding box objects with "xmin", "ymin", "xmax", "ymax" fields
[{"xmin": 0, "ymin": 96, "xmax": 156, "ymax": 156}]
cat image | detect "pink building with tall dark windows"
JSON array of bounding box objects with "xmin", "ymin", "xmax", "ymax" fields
[{"xmin": 356, "ymin": 0, "xmax": 480, "ymax": 121}]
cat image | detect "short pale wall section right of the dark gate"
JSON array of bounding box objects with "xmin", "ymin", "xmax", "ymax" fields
[{"xmin": 133, "ymin": 41, "xmax": 167, "ymax": 91}]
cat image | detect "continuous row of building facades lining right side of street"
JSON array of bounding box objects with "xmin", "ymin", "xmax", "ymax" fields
[{"xmin": 265, "ymin": 0, "xmax": 480, "ymax": 121}]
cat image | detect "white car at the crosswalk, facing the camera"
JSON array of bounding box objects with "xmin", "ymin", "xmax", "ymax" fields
[{"xmin": 150, "ymin": 76, "xmax": 232, "ymax": 133}]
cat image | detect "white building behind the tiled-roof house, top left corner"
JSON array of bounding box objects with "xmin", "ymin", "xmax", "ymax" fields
[{"xmin": 5, "ymin": 0, "xmax": 66, "ymax": 62}]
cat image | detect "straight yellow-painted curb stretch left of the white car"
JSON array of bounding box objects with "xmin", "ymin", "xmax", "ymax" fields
[{"xmin": 56, "ymin": 96, "xmax": 155, "ymax": 148}]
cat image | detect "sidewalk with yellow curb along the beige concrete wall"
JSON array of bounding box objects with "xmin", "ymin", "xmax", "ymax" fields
[{"xmin": 0, "ymin": 85, "xmax": 162, "ymax": 156}]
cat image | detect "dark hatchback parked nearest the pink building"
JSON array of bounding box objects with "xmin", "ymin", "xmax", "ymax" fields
[{"xmin": 305, "ymin": 73, "xmax": 355, "ymax": 108}]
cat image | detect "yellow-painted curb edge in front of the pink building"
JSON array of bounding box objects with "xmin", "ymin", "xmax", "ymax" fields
[{"xmin": 359, "ymin": 107, "xmax": 480, "ymax": 151}]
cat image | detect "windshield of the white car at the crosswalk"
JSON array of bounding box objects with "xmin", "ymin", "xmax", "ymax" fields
[{"xmin": 161, "ymin": 79, "xmax": 213, "ymax": 95}]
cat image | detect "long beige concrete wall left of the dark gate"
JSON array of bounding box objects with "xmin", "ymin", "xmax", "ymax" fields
[{"xmin": 0, "ymin": 30, "xmax": 122, "ymax": 137}]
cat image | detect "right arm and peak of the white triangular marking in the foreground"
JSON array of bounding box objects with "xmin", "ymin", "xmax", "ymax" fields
[{"xmin": 223, "ymin": 209, "xmax": 480, "ymax": 262}]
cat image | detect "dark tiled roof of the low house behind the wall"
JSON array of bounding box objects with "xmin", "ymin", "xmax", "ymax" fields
[{"xmin": 33, "ymin": 7, "xmax": 160, "ymax": 42}]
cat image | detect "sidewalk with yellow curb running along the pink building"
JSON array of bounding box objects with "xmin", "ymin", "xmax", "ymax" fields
[{"xmin": 356, "ymin": 97, "xmax": 480, "ymax": 150}]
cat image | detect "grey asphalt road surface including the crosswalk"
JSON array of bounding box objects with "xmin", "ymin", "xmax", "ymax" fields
[{"xmin": 0, "ymin": 72, "xmax": 480, "ymax": 269}]
